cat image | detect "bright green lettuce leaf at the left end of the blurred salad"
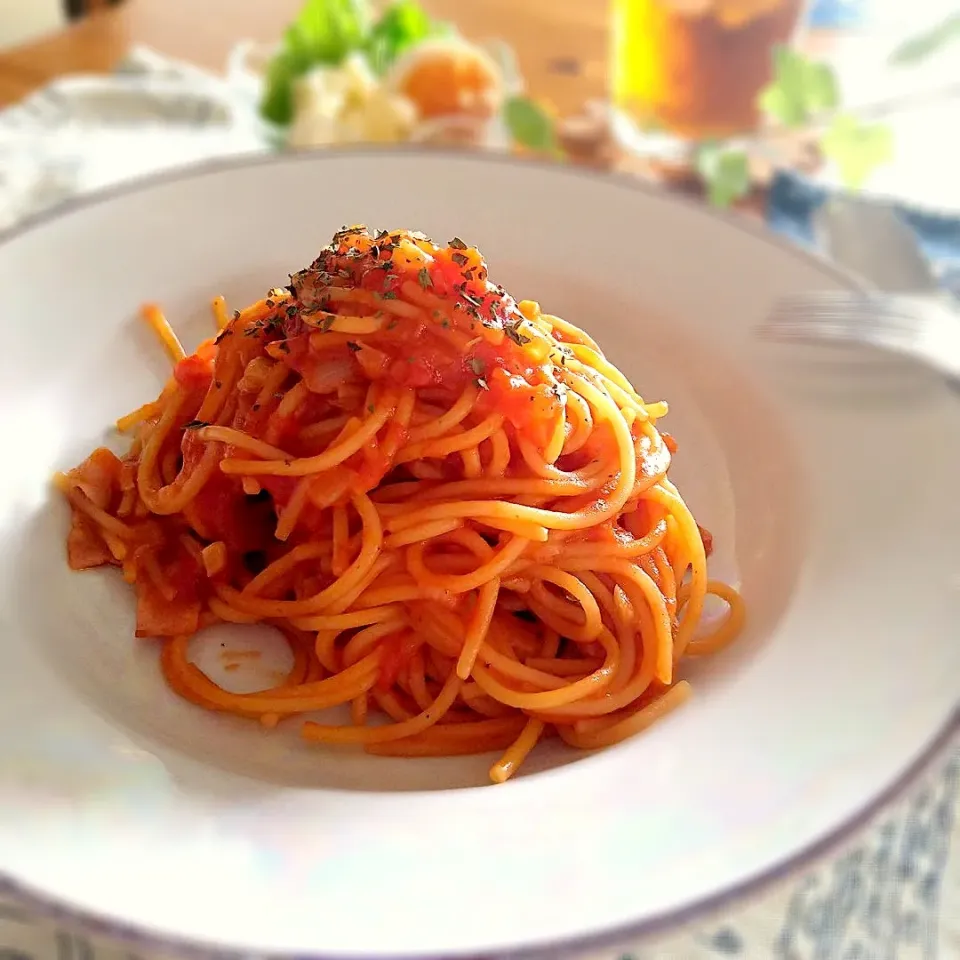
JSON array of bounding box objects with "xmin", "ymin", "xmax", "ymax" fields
[{"xmin": 260, "ymin": 0, "xmax": 370, "ymax": 125}]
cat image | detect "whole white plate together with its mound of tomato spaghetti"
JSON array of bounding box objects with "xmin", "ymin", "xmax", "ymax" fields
[{"xmin": 0, "ymin": 150, "xmax": 960, "ymax": 958}]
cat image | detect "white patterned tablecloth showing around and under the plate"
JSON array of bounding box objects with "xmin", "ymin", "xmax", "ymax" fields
[{"xmin": 0, "ymin": 50, "xmax": 960, "ymax": 960}]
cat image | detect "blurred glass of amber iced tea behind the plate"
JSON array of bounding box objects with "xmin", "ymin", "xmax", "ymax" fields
[{"xmin": 612, "ymin": 0, "xmax": 806, "ymax": 140}]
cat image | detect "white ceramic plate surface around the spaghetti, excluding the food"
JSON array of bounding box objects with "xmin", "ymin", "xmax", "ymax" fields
[{"xmin": 0, "ymin": 151, "xmax": 960, "ymax": 957}]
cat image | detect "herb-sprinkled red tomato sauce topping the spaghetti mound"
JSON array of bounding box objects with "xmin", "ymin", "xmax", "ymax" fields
[{"xmin": 275, "ymin": 229, "xmax": 563, "ymax": 446}]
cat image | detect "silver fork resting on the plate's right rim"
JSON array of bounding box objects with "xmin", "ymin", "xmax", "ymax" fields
[{"xmin": 759, "ymin": 291, "xmax": 960, "ymax": 381}]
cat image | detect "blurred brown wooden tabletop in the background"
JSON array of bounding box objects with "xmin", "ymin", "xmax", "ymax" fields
[{"xmin": 0, "ymin": 0, "xmax": 608, "ymax": 113}]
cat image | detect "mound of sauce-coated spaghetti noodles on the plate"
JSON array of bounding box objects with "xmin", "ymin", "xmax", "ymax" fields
[{"xmin": 57, "ymin": 227, "xmax": 743, "ymax": 782}]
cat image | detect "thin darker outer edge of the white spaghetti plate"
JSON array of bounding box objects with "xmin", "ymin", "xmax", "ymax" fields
[{"xmin": 0, "ymin": 144, "xmax": 960, "ymax": 960}]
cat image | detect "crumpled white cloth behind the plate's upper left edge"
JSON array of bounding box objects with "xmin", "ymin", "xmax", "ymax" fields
[{"xmin": 0, "ymin": 48, "xmax": 269, "ymax": 229}]
